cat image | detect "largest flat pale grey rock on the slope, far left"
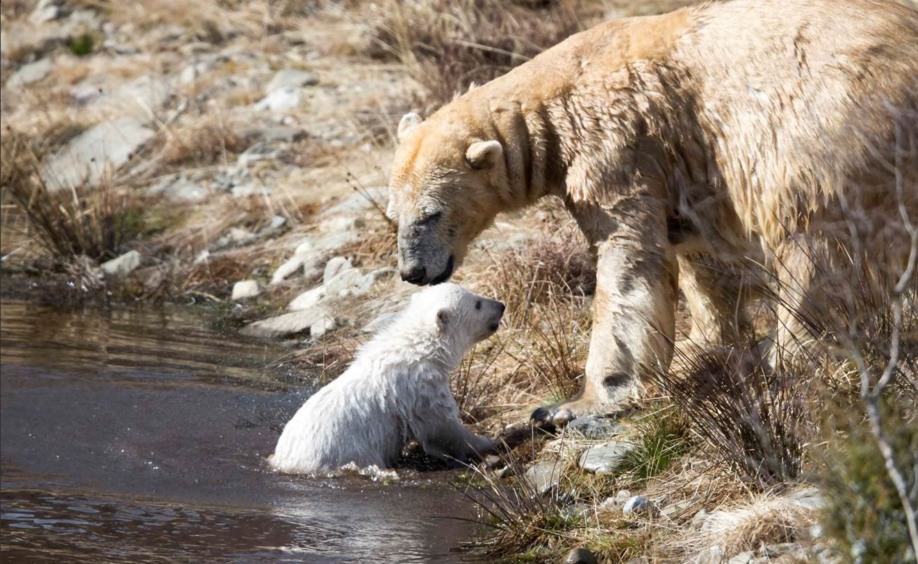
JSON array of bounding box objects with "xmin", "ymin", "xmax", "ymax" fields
[{"xmin": 42, "ymin": 117, "xmax": 155, "ymax": 191}]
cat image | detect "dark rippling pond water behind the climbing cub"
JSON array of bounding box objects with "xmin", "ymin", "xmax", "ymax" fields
[{"xmin": 0, "ymin": 302, "xmax": 486, "ymax": 563}]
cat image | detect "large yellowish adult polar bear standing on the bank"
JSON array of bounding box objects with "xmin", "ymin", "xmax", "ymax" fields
[{"xmin": 389, "ymin": 0, "xmax": 918, "ymax": 422}]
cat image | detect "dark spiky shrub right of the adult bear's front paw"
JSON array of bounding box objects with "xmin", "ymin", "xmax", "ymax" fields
[{"xmin": 651, "ymin": 349, "xmax": 809, "ymax": 489}]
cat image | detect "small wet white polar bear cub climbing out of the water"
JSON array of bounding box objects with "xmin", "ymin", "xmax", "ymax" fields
[{"xmin": 270, "ymin": 284, "xmax": 504, "ymax": 474}]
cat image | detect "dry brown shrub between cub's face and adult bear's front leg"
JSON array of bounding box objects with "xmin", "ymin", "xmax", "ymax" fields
[{"xmin": 478, "ymin": 228, "xmax": 596, "ymax": 327}]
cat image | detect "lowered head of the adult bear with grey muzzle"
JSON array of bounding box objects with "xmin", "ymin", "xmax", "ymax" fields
[{"xmin": 387, "ymin": 112, "xmax": 506, "ymax": 286}]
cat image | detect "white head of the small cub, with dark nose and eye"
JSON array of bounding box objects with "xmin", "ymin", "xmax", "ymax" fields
[{"xmin": 411, "ymin": 284, "xmax": 504, "ymax": 346}]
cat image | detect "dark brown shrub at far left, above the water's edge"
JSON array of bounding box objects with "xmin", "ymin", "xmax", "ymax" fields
[{"xmin": 0, "ymin": 129, "xmax": 149, "ymax": 261}]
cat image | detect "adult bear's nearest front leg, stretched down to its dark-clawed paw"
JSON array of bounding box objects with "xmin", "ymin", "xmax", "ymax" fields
[{"xmin": 532, "ymin": 194, "xmax": 678, "ymax": 426}]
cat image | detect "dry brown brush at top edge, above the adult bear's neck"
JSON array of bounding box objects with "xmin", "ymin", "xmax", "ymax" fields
[{"xmin": 369, "ymin": 0, "xmax": 582, "ymax": 104}]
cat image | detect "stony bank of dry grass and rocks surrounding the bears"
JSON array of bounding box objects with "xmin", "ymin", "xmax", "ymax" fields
[{"xmin": 2, "ymin": 0, "xmax": 916, "ymax": 564}]
